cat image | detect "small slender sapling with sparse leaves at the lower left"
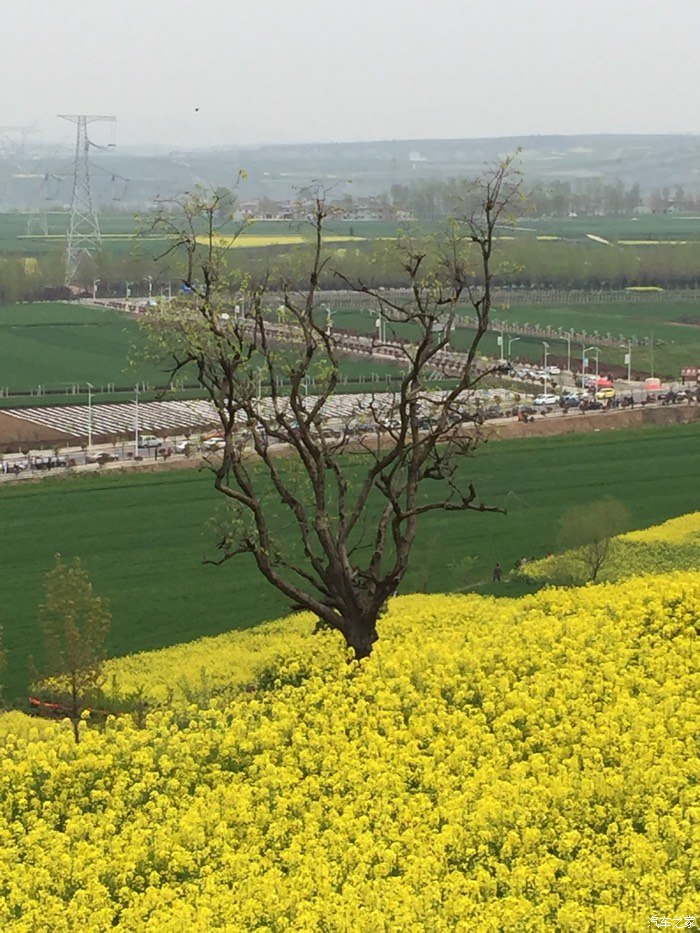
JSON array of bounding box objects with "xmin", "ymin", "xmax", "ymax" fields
[{"xmin": 35, "ymin": 554, "xmax": 111, "ymax": 742}]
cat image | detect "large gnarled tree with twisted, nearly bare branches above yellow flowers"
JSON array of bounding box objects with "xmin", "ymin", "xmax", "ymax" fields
[{"xmin": 147, "ymin": 158, "xmax": 520, "ymax": 658}]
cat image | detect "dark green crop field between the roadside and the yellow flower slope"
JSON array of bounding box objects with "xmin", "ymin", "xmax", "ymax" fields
[{"xmin": 0, "ymin": 425, "xmax": 700, "ymax": 699}]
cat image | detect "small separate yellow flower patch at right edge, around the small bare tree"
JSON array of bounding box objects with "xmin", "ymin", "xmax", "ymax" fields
[{"xmin": 520, "ymin": 512, "xmax": 700, "ymax": 584}]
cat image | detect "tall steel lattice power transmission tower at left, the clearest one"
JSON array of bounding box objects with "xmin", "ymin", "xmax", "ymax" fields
[{"xmin": 59, "ymin": 113, "xmax": 117, "ymax": 285}]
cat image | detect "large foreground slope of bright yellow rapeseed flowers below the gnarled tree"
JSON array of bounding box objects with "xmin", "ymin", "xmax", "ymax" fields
[{"xmin": 0, "ymin": 572, "xmax": 700, "ymax": 933}]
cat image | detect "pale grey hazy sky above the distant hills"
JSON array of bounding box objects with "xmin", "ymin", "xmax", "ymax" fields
[{"xmin": 5, "ymin": 0, "xmax": 700, "ymax": 148}]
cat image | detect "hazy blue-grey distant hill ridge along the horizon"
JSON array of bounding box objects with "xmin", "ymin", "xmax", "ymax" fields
[{"xmin": 0, "ymin": 135, "xmax": 700, "ymax": 211}]
